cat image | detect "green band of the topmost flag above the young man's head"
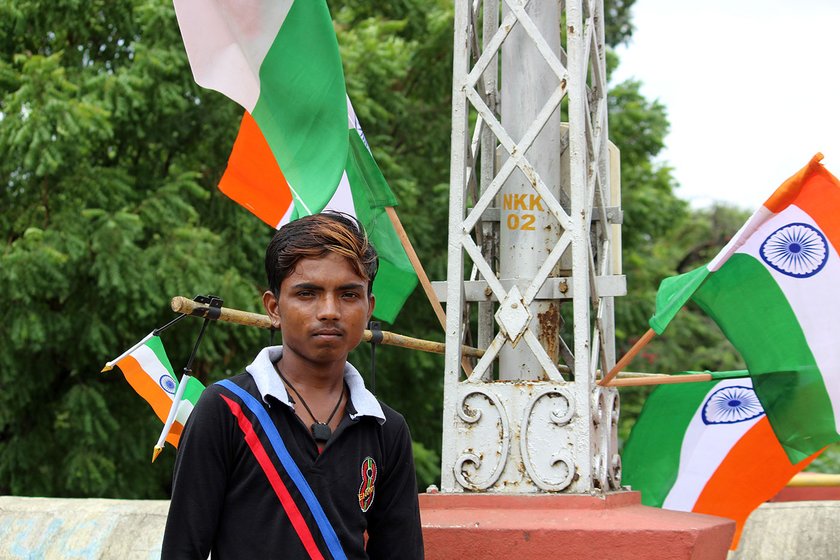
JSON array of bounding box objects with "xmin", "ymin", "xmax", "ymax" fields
[{"xmin": 251, "ymin": 0, "xmax": 347, "ymax": 215}]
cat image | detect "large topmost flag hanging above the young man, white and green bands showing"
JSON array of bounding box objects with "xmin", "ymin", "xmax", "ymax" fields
[{"xmin": 175, "ymin": 0, "xmax": 349, "ymax": 217}]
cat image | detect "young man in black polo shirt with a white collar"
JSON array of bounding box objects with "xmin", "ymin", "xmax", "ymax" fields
[{"xmin": 162, "ymin": 214, "xmax": 423, "ymax": 560}]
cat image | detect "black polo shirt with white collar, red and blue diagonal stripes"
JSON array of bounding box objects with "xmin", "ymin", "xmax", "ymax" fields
[{"xmin": 162, "ymin": 347, "xmax": 423, "ymax": 560}]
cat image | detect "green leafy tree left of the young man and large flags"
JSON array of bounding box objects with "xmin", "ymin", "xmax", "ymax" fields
[{"xmin": 0, "ymin": 0, "xmax": 270, "ymax": 498}]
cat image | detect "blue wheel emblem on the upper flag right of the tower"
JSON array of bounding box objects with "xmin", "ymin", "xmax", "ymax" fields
[{"xmin": 759, "ymin": 223, "xmax": 828, "ymax": 278}]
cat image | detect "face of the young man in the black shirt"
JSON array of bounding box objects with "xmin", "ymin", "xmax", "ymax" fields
[{"xmin": 263, "ymin": 253, "xmax": 374, "ymax": 367}]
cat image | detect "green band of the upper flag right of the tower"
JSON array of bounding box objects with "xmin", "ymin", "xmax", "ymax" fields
[{"xmin": 692, "ymin": 253, "xmax": 838, "ymax": 463}]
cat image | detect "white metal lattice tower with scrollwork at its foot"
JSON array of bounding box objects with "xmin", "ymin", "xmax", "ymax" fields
[{"xmin": 436, "ymin": 0, "xmax": 625, "ymax": 493}]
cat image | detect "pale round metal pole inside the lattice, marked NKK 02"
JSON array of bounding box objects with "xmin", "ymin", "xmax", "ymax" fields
[{"xmin": 497, "ymin": 2, "xmax": 566, "ymax": 380}]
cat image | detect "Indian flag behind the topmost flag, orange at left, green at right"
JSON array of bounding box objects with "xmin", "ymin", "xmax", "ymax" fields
[{"xmin": 219, "ymin": 100, "xmax": 417, "ymax": 323}]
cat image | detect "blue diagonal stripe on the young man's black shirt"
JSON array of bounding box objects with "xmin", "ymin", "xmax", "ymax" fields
[{"xmin": 218, "ymin": 379, "xmax": 347, "ymax": 560}]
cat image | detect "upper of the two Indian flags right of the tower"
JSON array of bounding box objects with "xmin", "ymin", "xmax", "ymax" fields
[{"xmin": 650, "ymin": 154, "xmax": 840, "ymax": 461}]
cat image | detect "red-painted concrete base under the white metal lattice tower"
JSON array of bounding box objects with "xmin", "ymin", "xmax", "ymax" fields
[{"xmin": 420, "ymin": 492, "xmax": 735, "ymax": 560}]
